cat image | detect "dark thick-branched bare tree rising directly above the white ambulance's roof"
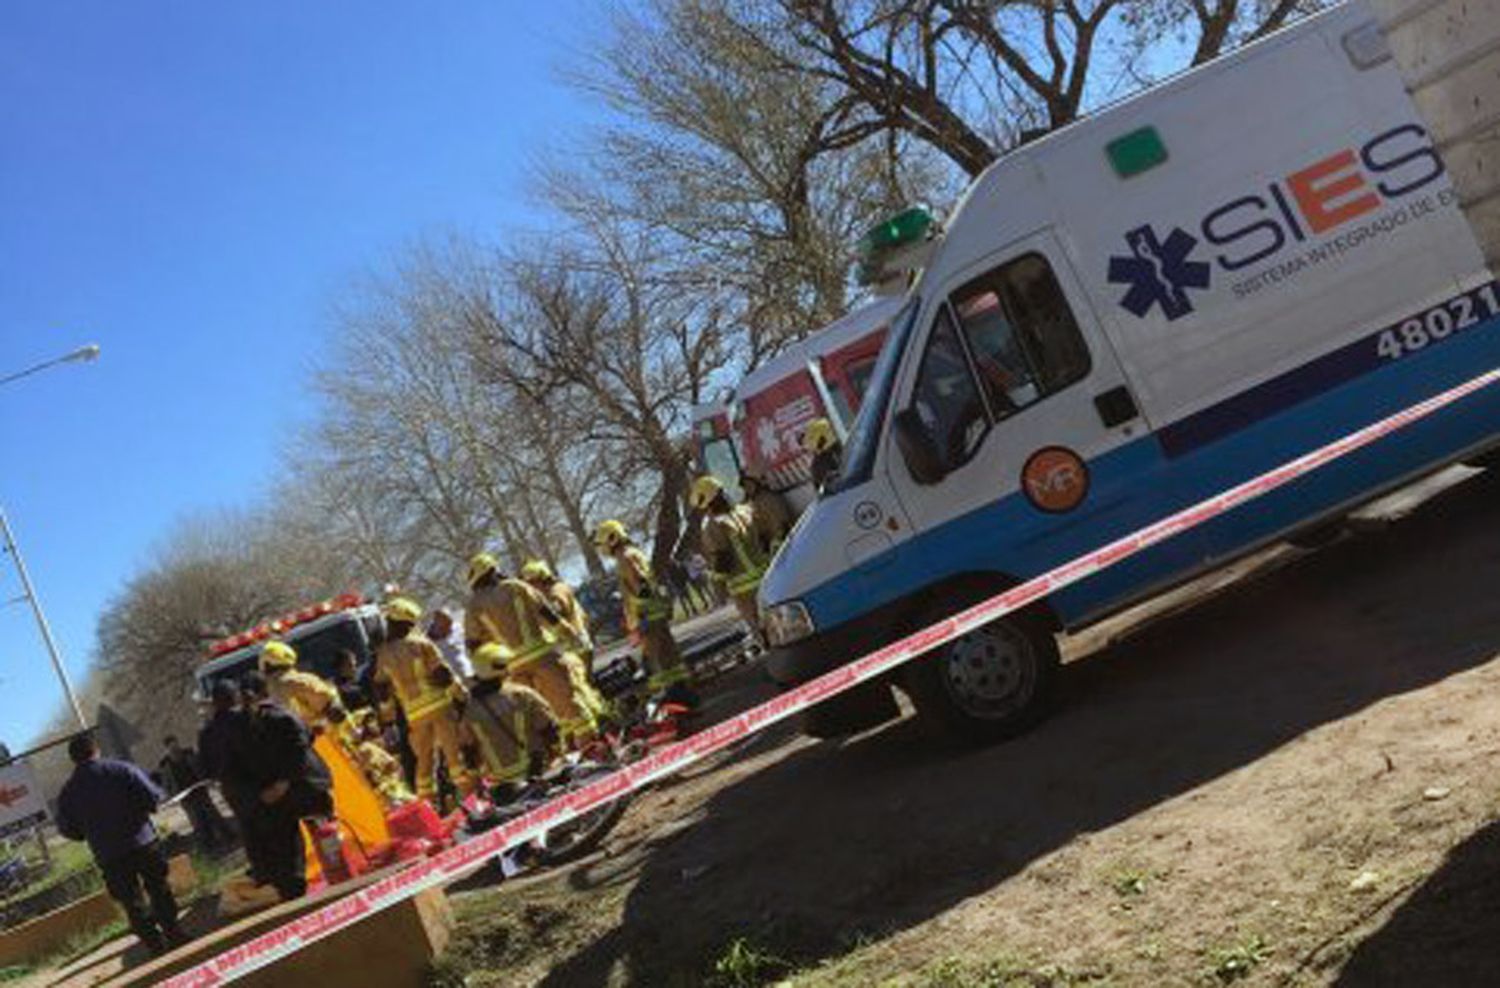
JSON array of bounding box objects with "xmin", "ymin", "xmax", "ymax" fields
[{"xmin": 678, "ymin": 0, "xmax": 1329, "ymax": 175}]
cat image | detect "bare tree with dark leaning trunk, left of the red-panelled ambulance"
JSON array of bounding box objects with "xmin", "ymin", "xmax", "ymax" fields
[{"xmin": 467, "ymin": 213, "xmax": 728, "ymax": 572}]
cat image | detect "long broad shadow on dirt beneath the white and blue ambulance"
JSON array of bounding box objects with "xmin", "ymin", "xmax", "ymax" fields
[{"xmin": 545, "ymin": 477, "xmax": 1500, "ymax": 987}]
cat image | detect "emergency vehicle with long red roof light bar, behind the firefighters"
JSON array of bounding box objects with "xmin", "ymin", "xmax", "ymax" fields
[{"xmin": 195, "ymin": 594, "xmax": 386, "ymax": 700}]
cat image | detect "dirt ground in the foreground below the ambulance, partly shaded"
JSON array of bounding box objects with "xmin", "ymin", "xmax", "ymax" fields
[{"xmin": 435, "ymin": 475, "xmax": 1500, "ymax": 987}]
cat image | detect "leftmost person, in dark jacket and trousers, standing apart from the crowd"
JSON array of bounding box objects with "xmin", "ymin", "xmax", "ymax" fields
[{"xmin": 57, "ymin": 735, "xmax": 186, "ymax": 954}]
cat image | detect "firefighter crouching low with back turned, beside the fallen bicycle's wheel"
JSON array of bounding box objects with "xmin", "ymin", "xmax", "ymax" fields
[{"xmin": 464, "ymin": 642, "xmax": 561, "ymax": 786}]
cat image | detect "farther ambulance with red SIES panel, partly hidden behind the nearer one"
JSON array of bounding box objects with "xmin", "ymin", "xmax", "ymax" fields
[{"xmin": 693, "ymin": 298, "xmax": 902, "ymax": 510}]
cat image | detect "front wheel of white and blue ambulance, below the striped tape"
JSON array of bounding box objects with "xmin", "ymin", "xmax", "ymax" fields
[{"xmin": 903, "ymin": 613, "xmax": 1062, "ymax": 745}]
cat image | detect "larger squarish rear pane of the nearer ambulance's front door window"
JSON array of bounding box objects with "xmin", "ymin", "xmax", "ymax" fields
[{"xmin": 950, "ymin": 253, "xmax": 1089, "ymax": 418}]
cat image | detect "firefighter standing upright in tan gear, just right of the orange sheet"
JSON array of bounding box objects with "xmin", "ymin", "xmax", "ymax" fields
[{"xmin": 375, "ymin": 597, "xmax": 474, "ymax": 799}]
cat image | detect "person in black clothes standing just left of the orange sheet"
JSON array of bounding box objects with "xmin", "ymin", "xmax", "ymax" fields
[{"xmin": 230, "ymin": 672, "xmax": 333, "ymax": 900}]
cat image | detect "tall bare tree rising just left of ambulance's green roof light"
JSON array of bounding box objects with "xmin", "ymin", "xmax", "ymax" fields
[{"xmin": 564, "ymin": 0, "xmax": 942, "ymax": 366}]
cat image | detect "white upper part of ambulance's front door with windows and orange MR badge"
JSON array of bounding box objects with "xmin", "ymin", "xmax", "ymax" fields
[{"xmin": 887, "ymin": 231, "xmax": 1146, "ymax": 537}]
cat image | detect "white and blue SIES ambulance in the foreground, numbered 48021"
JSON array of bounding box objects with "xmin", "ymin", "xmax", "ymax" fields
[{"xmin": 761, "ymin": 0, "xmax": 1500, "ymax": 742}]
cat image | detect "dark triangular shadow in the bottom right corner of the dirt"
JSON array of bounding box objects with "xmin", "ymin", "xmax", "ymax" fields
[{"xmin": 1335, "ymin": 823, "xmax": 1500, "ymax": 988}]
